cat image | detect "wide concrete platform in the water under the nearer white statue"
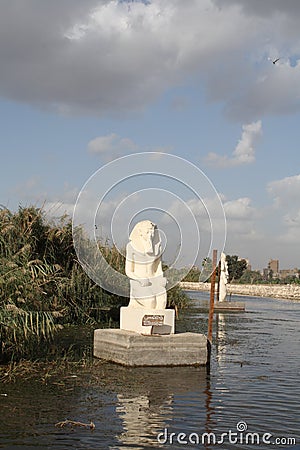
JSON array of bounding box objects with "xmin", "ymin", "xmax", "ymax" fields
[{"xmin": 94, "ymin": 329, "xmax": 208, "ymax": 367}]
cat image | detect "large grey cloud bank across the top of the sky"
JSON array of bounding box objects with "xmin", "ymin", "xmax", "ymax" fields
[{"xmin": 0, "ymin": 0, "xmax": 300, "ymax": 122}]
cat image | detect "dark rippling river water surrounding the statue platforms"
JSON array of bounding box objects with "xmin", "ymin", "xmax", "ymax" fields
[{"xmin": 0, "ymin": 292, "xmax": 300, "ymax": 450}]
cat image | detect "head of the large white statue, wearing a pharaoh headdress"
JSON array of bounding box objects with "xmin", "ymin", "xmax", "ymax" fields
[{"xmin": 129, "ymin": 220, "xmax": 160, "ymax": 255}]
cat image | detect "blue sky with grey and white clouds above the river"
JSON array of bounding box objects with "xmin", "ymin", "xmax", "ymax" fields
[{"xmin": 0, "ymin": 0, "xmax": 300, "ymax": 269}]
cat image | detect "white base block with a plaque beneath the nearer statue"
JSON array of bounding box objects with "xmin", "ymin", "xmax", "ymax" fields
[{"xmin": 120, "ymin": 306, "xmax": 175, "ymax": 335}]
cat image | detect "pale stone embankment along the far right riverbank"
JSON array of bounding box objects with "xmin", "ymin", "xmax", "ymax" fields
[{"xmin": 180, "ymin": 281, "xmax": 300, "ymax": 300}]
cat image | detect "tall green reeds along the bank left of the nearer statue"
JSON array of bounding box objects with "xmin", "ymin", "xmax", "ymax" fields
[{"xmin": 0, "ymin": 207, "xmax": 186, "ymax": 362}]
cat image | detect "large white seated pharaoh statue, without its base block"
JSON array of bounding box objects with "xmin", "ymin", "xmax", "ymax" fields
[{"xmin": 125, "ymin": 220, "xmax": 167, "ymax": 309}]
